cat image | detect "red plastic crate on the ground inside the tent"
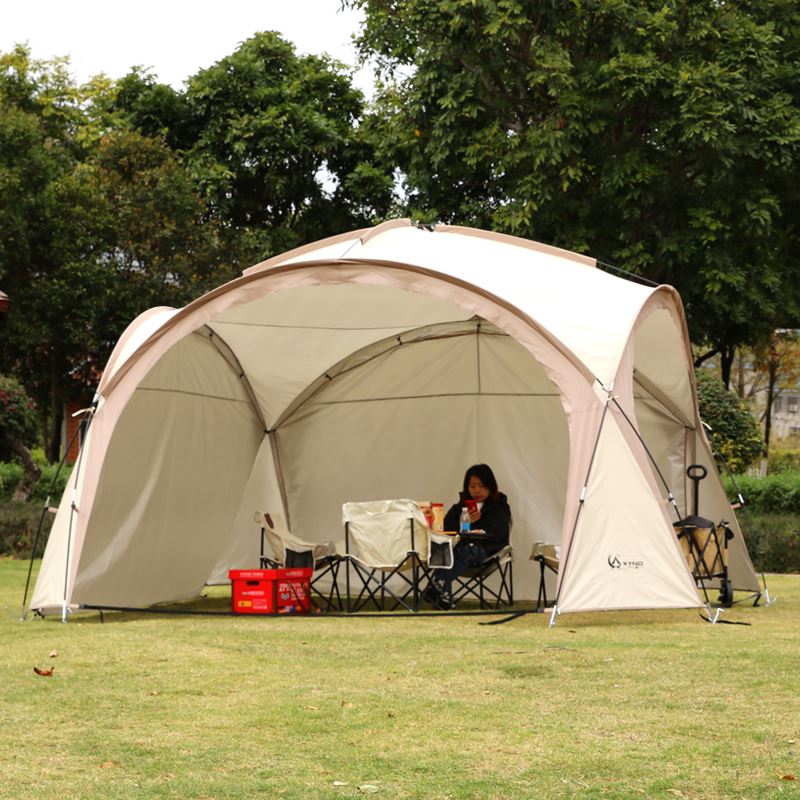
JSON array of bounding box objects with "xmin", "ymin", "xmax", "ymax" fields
[{"xmin": 228, "ymin": 568, "xmax": 313, "ymax": 614}]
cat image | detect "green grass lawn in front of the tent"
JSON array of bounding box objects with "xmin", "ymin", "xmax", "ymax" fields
[{"xmin": 0, "ymin": 560, "xmax": 800, "ymax": 800}]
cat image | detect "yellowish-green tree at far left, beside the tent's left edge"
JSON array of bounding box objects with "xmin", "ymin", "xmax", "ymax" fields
[{"xmin": 0, "ymin": 48, "xmax": 225, "ymax": 460}]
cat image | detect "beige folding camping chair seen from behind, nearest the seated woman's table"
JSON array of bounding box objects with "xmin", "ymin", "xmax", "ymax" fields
[{"xmin": 342, "ymin": 499, "xmax": 430, "ymax": 611}]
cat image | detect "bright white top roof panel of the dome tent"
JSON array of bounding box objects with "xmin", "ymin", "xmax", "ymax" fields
[{"xmin": 244, "ymin": 219, "xmax": 656, "ymax": 385}]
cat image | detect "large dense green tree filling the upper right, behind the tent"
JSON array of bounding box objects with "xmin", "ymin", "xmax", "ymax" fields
[{"xmin": 354, "ymin": 0, "xmax": 800, "ymax": 366}]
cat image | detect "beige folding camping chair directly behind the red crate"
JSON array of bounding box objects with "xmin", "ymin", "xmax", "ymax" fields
[{"xmin": 255, "ymin": 511, "xmax": 344, "ymax": 611}]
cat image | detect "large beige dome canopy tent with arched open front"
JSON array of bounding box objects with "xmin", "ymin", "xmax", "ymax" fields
[{"xmin": 31, "ymin": 220, "xmax": 758, "ymax": 614}]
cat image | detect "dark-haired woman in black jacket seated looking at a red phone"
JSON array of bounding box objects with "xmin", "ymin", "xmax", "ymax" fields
[{"xmin": 432, "ymin": 464, "xmax": 511, "ymax": 607}]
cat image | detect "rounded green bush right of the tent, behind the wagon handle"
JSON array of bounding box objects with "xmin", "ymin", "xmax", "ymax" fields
[{"xmin": 695, "ymin": 369, "xmax": 764, "ymax": 473}]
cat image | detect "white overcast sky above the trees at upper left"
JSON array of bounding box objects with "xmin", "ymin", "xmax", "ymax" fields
[{"xmin": 0, "ymin": 0, "xmax": 372, "ymax": 93}]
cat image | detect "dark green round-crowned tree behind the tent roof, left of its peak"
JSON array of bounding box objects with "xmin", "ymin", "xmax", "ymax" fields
[{"xmin": 111, "ymin": 33, "xmax": 392, "ymax": 268}]
